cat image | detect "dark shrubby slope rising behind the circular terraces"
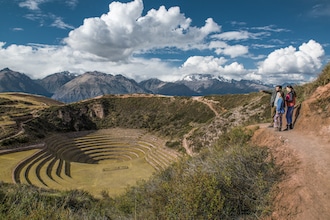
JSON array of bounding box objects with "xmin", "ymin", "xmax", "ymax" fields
[{"xmin": 27, "ymin": 96, "xmax": 214, "ymax": 143}]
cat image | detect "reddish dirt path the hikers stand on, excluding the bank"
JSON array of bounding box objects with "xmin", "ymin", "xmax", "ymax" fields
[{"xmin": 253, "ymin": 125, "xmax": 330, "ymax": 220}]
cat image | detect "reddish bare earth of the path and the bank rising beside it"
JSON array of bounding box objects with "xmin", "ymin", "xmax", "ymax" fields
[{"xmin": 252, "ymin": 84, "xmax": 330, "ymax": 220}]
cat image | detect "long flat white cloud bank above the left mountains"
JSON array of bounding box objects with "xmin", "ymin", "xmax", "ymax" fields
[{"xmin": 0, "ymin": 42, "xmax": 181, "ymax": 81}]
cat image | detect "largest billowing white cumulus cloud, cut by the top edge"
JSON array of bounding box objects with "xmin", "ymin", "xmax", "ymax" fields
[{"xmin": 64, "ymin": 0, "xmax": 220, "ymax": 61}]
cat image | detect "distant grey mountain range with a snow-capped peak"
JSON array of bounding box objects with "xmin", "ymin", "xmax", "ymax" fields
[{"xmin": 0, "ymin": 68, "xmax": 273, "ymax": 103}]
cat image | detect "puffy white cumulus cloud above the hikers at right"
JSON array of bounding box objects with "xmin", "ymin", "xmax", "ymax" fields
[{"xmin": 258, "ymin": 40, "xmax": 324, "ymax": 81}]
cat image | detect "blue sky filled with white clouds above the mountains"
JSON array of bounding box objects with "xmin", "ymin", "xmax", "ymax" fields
[{"xmin": 0, "ymin": 0, "xmax": 330, "ymax": 84}]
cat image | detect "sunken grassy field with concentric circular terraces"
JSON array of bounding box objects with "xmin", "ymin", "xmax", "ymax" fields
[{"xmin": 0, "ymin": 128, "xmax": 180, "ymax": 197}]
